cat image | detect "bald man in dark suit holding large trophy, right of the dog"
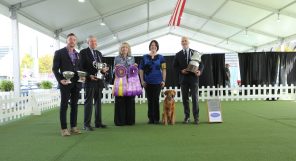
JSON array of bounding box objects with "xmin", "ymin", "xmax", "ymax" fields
[{"xmin": 174, "ymin": 37, "xmax": 204, "ymax": 124}]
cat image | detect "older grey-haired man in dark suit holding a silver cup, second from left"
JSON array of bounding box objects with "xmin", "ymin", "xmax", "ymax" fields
[{"xmin": 80, "ymin": 36, "xmax": 109, "ymax": 131}]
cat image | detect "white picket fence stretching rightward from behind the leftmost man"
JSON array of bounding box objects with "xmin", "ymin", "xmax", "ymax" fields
[{"xmin": 79, "ymin": 85, "xmax": 296, "ymax": 104}]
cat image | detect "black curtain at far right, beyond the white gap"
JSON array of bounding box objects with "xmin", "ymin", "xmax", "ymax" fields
[{"xmin": 238, "ymin": 52, "xmax": 296, "ymax": 85}]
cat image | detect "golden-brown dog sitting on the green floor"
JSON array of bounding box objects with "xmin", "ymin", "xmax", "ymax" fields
[{"xmin": 162, "ymin": 90, "xmax": 176, "ymax": 125}]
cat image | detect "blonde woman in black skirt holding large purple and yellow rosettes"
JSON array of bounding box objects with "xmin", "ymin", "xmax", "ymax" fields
[{"xmin": 113, "ymin": 42, "xmax": 142, "ymax": 126}]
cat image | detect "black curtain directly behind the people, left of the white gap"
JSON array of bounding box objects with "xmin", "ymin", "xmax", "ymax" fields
[{"xmin": 103, "ymin": 54, "xmax": 225, "ymax": 87}]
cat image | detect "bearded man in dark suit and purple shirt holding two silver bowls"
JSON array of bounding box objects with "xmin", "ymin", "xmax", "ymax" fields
[{"xmin": 52, "ymin": 33, "xmax": 81, "ymax": 136}]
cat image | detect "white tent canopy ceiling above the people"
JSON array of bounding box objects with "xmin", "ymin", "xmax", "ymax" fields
[{"xmin": 0, "ymin": 0, "xmax": 296, "ymax": 55}]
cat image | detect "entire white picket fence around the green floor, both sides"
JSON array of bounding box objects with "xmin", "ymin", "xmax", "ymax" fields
[{"xmin": 0, "ymin": 85, "xmax": 296, "ymax": 124}]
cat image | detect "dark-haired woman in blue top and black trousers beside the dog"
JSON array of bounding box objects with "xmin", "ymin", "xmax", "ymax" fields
[{"xmin": 139, "ymin": 40, "xmax": 166, "ymax": 124}]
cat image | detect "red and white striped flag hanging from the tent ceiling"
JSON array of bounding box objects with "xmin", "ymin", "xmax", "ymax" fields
[{"xmin": 169, "ymin": 0, "xmax": 186, "ymax": 26}]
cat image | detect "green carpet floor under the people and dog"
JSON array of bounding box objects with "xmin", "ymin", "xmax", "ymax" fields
[{"xmin": 0, "ymin": 101, "xmax": 296, "ymax": 161}]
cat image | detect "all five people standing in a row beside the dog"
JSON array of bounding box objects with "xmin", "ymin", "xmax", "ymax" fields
[{"xmin": 52, "ymin": 33, "xmax": 204, "ymax": 136}]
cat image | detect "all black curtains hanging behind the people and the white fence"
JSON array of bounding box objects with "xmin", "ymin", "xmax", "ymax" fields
[{"xmin": 103, "ymin": 52, "xmax": 296, "ymax": 87}]
